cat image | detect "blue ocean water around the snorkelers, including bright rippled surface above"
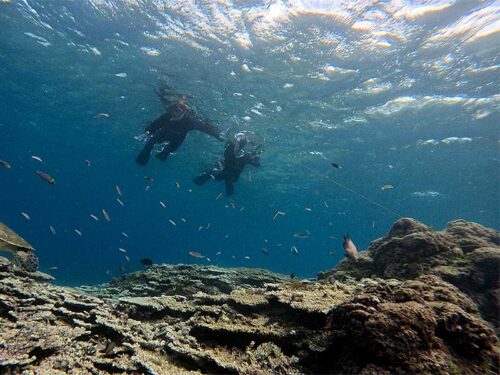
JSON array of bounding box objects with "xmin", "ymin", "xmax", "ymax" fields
[{"xmin": 0, "ymin": 0, "xmax": 500, "ymax": 285}]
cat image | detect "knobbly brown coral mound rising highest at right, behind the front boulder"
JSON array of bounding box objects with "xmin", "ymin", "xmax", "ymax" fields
[{"xmin": 319, "ymin": 218, "xmax": 500, "ymax": 329}]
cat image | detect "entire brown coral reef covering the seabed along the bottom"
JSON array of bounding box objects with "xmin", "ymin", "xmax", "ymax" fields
[{"xmin": 0, "ymin": 219, "xmax": 500, "ymax": 374}]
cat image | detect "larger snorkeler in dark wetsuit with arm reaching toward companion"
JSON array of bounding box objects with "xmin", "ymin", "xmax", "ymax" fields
[{"xmin": 136, "ymin": 92, "xmax": 222, "ymax": 165}]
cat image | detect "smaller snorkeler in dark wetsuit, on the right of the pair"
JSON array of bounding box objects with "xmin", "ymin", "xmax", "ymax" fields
[{"xmin": 193, "ymin": 133, "xmax": 260, "ymax": 196}]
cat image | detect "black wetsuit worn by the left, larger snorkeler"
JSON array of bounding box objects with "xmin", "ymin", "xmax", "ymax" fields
[{"xmin": 136, "ymin": 113, "xmax": 222, "ymax": 165}]
